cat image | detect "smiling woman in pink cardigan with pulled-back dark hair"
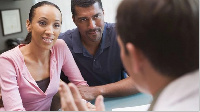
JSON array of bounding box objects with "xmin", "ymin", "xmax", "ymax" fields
[{"xmin": 0, "ymin": 1, "xmax": 87, "ymax": 111}]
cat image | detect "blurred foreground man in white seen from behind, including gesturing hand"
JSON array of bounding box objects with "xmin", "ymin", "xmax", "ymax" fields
[{"xmin": 60, "ymin": 0, "xmax": 199, "ymax": 111}]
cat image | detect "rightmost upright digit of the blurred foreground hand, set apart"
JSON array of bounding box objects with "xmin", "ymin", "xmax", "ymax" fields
[{"xmin": 95, "ymin": 95, "xmax": 105, "ymax": 111}]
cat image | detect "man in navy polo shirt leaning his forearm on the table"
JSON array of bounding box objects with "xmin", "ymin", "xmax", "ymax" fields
[{"xmin": 59, "ymin": 0, "xmax": 137, "ymax": 100}]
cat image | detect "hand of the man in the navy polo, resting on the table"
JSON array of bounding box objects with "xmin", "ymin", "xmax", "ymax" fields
[{"xmin": 77, "ymin": 85, "xmax": 100, "ymax": 101}]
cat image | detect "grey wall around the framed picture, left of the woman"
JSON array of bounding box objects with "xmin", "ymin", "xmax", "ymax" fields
[{"xmin": 0, "ymin": 0, "xmax": 35, "ymax": 51}]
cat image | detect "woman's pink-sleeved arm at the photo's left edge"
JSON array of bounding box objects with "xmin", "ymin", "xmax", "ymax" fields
[{"xmin": 0, "ymin": 57, "xmax": 25, "ymax": 111}]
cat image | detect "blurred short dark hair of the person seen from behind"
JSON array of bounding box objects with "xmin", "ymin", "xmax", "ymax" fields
[{"xmin": 116, "ymin": 0, "xmax": 199, "ymax": 77}]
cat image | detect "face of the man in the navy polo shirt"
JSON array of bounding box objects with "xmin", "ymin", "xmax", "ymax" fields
[{"xmin": 73, "ymin": 2, "xmax": 104, "ymax": 42}]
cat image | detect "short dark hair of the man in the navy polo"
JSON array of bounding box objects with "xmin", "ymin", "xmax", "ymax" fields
[{"xmin": 71, "ymin": 0, "xmax": 103, "ymax": 16}]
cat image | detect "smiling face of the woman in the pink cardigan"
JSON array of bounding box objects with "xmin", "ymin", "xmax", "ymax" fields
[{"xmin": 27, "ymin": 5, "xmax": 62, "ymax": 50}]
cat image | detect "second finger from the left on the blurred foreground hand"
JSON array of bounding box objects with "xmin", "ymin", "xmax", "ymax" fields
[{"xmin": 69, "ymin": 83, "xmax": 88, "ymax": 111}]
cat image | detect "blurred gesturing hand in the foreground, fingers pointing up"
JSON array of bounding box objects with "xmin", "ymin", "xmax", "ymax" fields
[{"xmin": 59, "ymin": 82, "xmax": 104, "ymax": 111}]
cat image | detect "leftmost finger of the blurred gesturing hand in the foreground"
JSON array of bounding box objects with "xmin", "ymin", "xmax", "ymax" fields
[{"xmin": 59, "ymin": 82, "xmax": 78, "ymax": 111}]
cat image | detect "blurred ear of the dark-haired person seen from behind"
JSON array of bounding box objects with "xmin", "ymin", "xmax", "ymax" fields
[{"xmin": 126, "ymin": 43, "xmax": 143, "ymax": 73}]
